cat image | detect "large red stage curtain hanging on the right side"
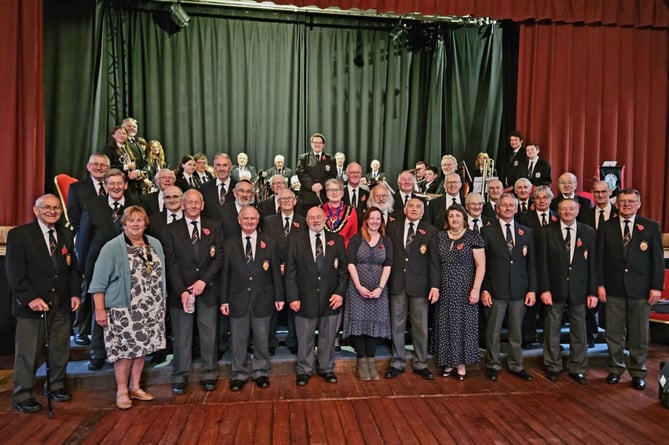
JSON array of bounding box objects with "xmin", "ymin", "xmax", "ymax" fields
[{"xmin": 517, "ymin": 24, "xmax": 669, "ymax": 227}]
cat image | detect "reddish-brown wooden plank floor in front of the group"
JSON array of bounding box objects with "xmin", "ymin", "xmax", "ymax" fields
[{"xmin": 0, "ymin": 345, "xmax": 669, "ymax": 445}]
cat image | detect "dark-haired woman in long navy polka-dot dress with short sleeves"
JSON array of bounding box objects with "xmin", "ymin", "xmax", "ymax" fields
[{"xmin": 430, "ymin": 204, "xmax": 485, "ymax": 380}]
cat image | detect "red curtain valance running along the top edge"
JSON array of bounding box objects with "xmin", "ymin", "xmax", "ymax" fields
[{"xmin": 264, "ymin": 0, "xmax": 669, "ymax": 27}]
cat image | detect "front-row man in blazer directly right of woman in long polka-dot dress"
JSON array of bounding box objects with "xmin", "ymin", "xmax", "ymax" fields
[{"xmin": 481, "ymin": 193, "xmax": 537, "ymax": 381}]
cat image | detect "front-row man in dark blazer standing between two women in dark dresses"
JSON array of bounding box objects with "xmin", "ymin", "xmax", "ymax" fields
[{"xmin": 385, "ymin": 198, "xmax": 439, "ymax": 380}]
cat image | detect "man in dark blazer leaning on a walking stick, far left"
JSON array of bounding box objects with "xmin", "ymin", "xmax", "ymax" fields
[{"xmin": 5, "ymin": 195, "xmax": 81, "ymax": 413}]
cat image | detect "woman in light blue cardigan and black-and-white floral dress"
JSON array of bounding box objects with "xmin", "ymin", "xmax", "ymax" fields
[{"xmin": 88, "ymin": 206, "xmax": 167, "ymax": 409}]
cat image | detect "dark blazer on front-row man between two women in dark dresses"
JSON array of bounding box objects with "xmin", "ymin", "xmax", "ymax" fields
[{"xmin": 386, "ymin": 218, "xmax": 439, "ymax": 298}]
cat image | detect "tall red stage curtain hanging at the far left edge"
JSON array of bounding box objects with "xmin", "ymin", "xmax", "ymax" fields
[{"xmin": 0, "ymin": 0, "xmax": 44, "ymax": 226}]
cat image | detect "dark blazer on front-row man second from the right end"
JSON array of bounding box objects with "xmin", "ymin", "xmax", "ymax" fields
[{"xmin": 537, "ymin": 221, "xmax": 597, "ymax": 305}]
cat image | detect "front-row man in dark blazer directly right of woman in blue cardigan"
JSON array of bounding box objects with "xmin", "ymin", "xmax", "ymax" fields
[{"xmin": 163, "ymin": 189, "xmax": 223, "ymax": 395}]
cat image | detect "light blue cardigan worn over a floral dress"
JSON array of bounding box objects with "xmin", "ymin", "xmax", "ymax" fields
[{"xmin": 88, "ymin": 233, "xmax": 167, "ymax": 308}]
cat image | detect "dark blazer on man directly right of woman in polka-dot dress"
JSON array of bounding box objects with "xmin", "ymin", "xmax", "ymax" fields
[{"xmin": 481, "ymin": 222, "xmax": 538, "ymax": 300}]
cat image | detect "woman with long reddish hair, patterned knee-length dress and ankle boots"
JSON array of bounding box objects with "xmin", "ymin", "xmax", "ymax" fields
[{"xmin": 344, "ymin": 207, "xmax": 393, "ymax": 380}]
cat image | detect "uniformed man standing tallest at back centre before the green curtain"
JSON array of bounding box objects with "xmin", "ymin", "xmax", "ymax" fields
[{"xmin": 295, "ymin": 133, "xmax": 337, "ymax": 208}]
